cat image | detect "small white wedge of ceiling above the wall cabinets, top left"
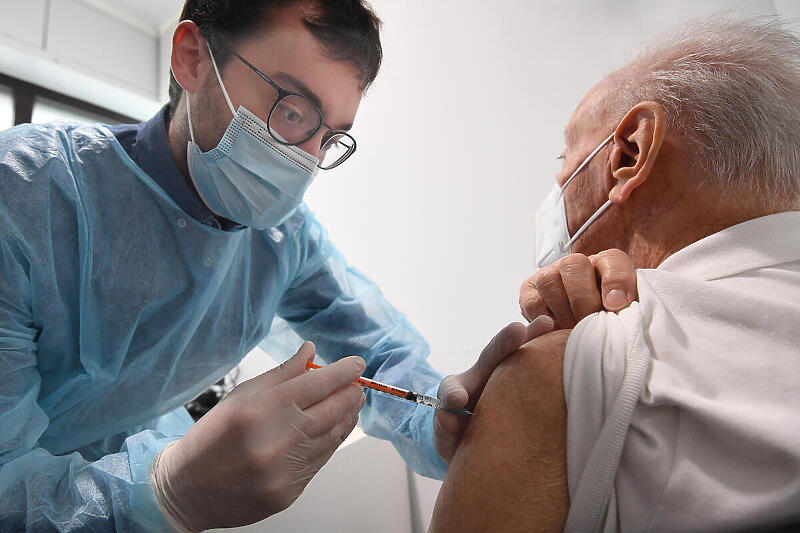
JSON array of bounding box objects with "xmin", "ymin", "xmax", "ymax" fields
[{"xmin": 74, "ymin": 0, "xmax": 183, "ymax": 37}]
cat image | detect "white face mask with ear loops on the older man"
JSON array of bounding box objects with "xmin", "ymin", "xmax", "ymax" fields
[{"xmin": 536, "ymin": 133, "xmax": 614, "ymax": 269}]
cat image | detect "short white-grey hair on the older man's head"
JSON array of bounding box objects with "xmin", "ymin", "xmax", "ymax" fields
[{"xmin": 611, "ymin": 15, "xmax": 800, "ymax": 207}]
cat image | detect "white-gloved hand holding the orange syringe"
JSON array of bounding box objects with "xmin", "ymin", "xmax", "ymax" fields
[{"xmin": 151, "ymin": 342, "xmax": 366, "ymax": 531}]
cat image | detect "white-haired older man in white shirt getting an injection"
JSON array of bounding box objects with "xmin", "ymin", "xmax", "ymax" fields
[{"xmin": 432, "ymin": 18, "xmax": 800, "ymax": 531}]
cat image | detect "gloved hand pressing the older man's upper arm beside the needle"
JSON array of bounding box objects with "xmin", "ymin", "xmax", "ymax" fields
[{"xmin": 433, "ymin": 315, "xmax": 554, "ymax": 464}]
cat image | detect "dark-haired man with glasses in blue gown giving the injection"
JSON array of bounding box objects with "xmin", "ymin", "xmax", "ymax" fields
[{"xmin": 0, "ymin": 0, "xmax": 438, "ymax": 531}]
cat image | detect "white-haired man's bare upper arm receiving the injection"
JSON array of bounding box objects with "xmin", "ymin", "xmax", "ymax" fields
[{"xmin": 431, "ymin": 330, "xmax": 570, "ymax": 531}]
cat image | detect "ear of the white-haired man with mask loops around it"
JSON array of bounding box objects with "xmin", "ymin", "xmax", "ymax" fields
[{"xmin": 608, "ymin": 101, "xmax": 667, "ymax": 204}]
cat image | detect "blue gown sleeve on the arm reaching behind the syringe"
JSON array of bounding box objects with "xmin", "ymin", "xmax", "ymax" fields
[{"xmin": 267, "ymin": 206, "xmax": 447, "ymax": 479}]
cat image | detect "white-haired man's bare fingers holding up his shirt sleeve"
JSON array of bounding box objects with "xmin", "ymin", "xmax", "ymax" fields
[{"xmin": 519, "ymin": 249, "xmax": 639, "ymax": 329}]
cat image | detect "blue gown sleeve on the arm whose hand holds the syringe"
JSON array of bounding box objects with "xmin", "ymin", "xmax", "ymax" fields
[{"xmin": 0, "ymin": 238, "xmax": 175, "ymax": 532}]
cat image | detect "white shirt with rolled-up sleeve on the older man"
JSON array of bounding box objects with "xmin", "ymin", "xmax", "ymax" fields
[{"xmin": 564, "ymin": 211, "xmax": 800, "ymax": 532}]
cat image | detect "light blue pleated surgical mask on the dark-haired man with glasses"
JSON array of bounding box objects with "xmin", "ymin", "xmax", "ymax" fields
[{"xmin": 186, "ymin": 43, "xmax": 319, "ymax": 230}]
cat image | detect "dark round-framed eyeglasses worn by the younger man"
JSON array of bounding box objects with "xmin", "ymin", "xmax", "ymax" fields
[{"xmin": 233, "ymin": 52, "xmax": 356, "ymax": 170}]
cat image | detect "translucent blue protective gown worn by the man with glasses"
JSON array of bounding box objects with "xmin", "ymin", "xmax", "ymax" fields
[{"xmin": 0, "ymin": 118, "xmax": 445, "ymax": 531}]
